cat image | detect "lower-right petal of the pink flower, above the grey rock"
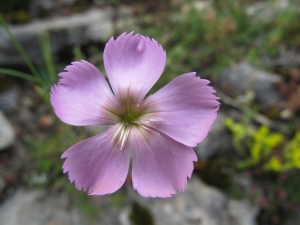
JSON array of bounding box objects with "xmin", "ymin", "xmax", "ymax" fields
[{"xmin": 130, "ymin": 127, "xmax": 197, "ymax": 198}]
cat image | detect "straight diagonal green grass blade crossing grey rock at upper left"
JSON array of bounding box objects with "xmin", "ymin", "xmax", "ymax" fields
[{"xmin": 0, "ymin": 14, "xmax": 39, "ymax": 79}]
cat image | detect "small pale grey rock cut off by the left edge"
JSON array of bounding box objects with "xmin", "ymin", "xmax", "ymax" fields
[{"xmin": 0, "ymin": 111, "xmax": 15, "ymax": 151}]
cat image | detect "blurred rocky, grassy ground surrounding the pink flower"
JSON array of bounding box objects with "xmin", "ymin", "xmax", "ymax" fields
[{"xmin": 0, "ymin": 0, "xmax": 300, "ymax": 225}]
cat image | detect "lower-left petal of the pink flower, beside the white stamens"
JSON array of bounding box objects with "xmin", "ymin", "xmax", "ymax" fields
[{"xmin": 62, "ymin": 124, "xmax": 130, "ymax": 195}]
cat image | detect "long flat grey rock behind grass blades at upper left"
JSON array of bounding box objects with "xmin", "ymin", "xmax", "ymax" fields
[{"xmin": 0, "ymin": 7, "xmax": 113, "ymax": 65}]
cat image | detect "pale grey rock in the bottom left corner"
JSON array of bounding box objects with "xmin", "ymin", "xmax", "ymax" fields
[{"xmin": 0, "ymin": 190, "xmax": 121, "ymax": 225}]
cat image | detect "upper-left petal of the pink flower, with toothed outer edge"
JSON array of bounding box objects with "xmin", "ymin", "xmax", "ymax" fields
[{"xmin": 51, "ymin": 61, "xmax": 123, "ymax": 126}]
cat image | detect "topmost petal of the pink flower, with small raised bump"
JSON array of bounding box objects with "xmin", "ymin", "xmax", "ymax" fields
[{"xmin": 104, "ymin": 33, "xmax": 166, "ymax": 103}]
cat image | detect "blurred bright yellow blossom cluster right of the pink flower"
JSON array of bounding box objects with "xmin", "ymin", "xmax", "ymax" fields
[{"xmin": 225, "ymin": 118, "xmax": 300, "ymax": 172}]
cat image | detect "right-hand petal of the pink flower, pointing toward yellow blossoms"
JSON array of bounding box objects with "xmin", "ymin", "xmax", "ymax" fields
[{"xmin": 140, "ymin": 73, "xmax": 219, "ymax": 147}]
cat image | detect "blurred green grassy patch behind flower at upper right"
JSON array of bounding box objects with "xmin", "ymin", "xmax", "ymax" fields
[{"xmin": 132, "ymin": 0, "xmax": 300, "ymax": 86}]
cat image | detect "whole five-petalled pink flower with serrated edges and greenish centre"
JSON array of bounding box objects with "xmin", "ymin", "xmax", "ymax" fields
[{"xmin": 51, "ymin": 33, "xmax": 219, "ymax": 197}]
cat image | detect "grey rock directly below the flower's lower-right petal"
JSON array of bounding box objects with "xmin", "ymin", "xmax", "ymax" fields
[{"xmin": 130, "ymin": 177, "xmax": 259, "ymax": 225}]
